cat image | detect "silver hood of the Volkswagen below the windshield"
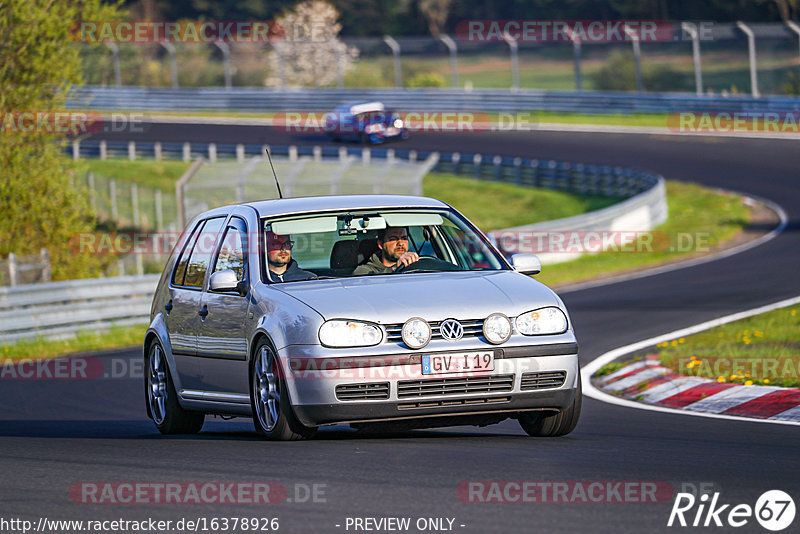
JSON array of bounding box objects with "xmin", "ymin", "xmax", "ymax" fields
[{"xmin": 279, "ymin": 271, "xmax": 559, "ymax": 324}]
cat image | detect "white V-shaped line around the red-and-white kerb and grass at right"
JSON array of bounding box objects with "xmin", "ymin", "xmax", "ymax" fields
[{"xmin": 581, "ymin": 296, "xmax": 800, "ymax": 426}]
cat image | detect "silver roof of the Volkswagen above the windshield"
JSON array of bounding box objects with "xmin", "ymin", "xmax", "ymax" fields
[{"xmin": 245, "ymin": 195, "xmax": 450, "ymax": 217}]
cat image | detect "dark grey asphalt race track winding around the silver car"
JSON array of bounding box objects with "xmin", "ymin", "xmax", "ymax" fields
[{"xmin": 0, "ymin": 124, "xmax": 800, "ymax": 533}]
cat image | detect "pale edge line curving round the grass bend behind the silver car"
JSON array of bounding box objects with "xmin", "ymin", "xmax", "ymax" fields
[{"xmin": 557, "ymin": 194, "xmax": 789, "ymax": 294}]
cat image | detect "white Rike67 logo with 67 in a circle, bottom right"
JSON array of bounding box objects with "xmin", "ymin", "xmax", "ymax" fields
[{"xmin": 667, "ymin": 490, "xmax": 795, "ymax": 532}]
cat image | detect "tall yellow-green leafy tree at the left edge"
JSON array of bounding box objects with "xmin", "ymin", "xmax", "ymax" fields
[{"xmin": 0, "ymin": 0, "xmax": 119, "ymax": 278}]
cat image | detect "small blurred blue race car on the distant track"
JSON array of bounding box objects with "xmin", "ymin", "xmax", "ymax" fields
[{"xmin": 325, "ymin": 102, "xmax": 408, "ymax": 144}]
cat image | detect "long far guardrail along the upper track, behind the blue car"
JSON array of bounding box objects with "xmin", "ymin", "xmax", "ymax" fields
[{"xmin": 67, "ymin": 86, "xmax": 800, "ymax": 114}]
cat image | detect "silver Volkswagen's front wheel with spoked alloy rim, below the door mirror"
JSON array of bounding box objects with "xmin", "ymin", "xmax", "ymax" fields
[{"xmin": 250, "ymin": 339, "xmax": 317, "ymax": 441}]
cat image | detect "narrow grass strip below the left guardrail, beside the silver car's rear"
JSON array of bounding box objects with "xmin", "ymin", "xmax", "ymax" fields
[{"xmin": 0, "ymin": 324, "xmax": 147, "ymax": 360}]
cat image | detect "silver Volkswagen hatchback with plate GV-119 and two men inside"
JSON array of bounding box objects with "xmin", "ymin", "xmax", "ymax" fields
[{"xmin": 144, "ymin": 195, "xmax": 581, "ymax": 440}]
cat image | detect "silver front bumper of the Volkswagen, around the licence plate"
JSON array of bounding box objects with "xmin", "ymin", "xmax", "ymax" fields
[{"xmin": 284, "ymin": 342, "xmax": 579, "ymax": 426}]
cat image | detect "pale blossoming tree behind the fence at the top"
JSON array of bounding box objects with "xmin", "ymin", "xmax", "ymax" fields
[{"xmin": 265, "ymin": 0, "xmax": 358, "ymax": 86}]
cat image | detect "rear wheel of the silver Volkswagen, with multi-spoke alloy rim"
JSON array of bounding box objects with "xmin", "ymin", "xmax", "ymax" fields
[{"xmin": 145, "ymin": 341, "xmax": 206, "ymax": 434}]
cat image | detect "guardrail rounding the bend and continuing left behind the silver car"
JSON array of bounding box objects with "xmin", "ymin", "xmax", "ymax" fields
[{"xmin": 6, "ymin": 142, "xmax": 667, "ymax": 344}]
